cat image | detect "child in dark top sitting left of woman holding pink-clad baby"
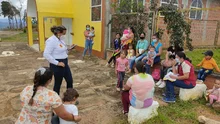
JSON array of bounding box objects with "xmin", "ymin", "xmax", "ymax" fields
[{"xmin": 105, "ymin": 33, "xmax": 121, "ymax": 67}]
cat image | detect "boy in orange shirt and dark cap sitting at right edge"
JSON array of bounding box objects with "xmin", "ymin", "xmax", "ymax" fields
[{"xmin": 197, "ymin": 50, "xmax": 220, "ymax": 82}]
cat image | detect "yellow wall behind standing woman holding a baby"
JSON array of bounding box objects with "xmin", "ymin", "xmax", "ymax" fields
[{"xmin": 72, "ymin": 0, "xmax": 102, "ymax": 51}]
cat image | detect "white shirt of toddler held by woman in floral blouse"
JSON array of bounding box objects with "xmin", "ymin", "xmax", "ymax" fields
[{"xmin": 60, "ymin": 104, "xmax": 78, "ymax": 124}]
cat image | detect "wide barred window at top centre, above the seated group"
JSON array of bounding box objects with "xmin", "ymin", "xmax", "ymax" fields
[{"xmin": 118, "ymin": 0, "xmax": 145, "ymax": 13}]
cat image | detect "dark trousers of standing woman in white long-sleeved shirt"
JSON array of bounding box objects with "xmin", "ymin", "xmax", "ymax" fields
[{"xmin": 50, "ymin": 59, "xmax": 73, "ymax": 94}]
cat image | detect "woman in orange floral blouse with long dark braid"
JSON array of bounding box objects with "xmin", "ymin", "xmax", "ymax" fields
[{"xmin": 16, "ymin": 67, "xmax": 80, "ymax": 124}]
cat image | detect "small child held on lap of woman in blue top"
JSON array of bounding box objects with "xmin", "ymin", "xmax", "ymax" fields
[{"xmin": 147, "ymin": 45, "xmax": 157, "ymax": 67}]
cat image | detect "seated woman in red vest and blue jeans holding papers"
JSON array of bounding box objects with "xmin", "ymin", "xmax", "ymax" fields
[{"xmin": 163, "ymin": 52, "xmax": 196, "ymax": 102}]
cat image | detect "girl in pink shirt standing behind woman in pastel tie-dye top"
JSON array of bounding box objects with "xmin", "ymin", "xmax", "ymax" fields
[{"xmin": 115, "ymin": 50, "xmax": 128, "ymax": 91}]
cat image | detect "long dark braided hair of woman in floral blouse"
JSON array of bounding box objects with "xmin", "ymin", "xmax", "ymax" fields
[{"xmin": 28, "ymin": 67, "xmax": 53, "ymax": 106}]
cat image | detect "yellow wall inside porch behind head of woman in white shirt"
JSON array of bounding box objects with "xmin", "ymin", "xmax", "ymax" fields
[{"xmin": 44, "ymin": 18, "xmax": 62, "ymax": 38}]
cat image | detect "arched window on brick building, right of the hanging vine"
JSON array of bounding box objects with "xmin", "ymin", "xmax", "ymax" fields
[{"xmin": 189, "ymin": 0, "xmax": 202, "ymax": 20}]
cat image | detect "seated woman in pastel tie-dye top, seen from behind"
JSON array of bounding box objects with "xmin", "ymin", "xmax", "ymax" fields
[{"xmin": 122, "ymin": 61, "xmax": 154, "ymax": 114}]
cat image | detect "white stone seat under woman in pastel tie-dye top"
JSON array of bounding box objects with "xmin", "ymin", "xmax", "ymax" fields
[{"xmin": 128, "ymin": 101, "xmax": 159, "ymax": 124}]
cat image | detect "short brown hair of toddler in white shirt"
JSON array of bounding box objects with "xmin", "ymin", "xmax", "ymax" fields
[{"xmin": 63, "ymin": 88, "xmax": 79, "ymax": 102}]
